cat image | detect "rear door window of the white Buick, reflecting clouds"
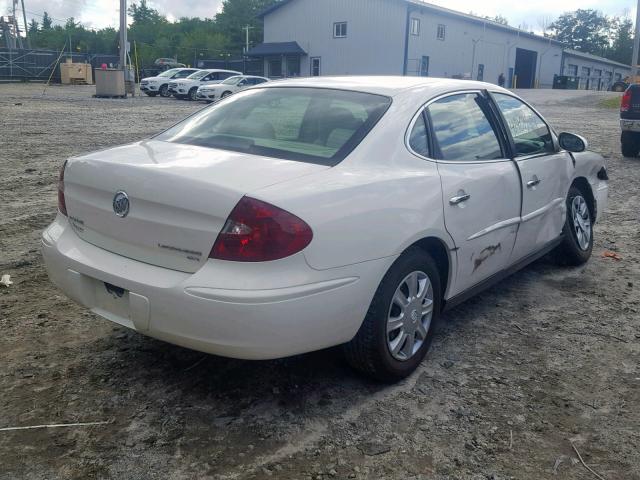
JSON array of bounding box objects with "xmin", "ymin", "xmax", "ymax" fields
[{"xmin": 428, "ymin": 93, "xmax": 504, "ymax": 162}]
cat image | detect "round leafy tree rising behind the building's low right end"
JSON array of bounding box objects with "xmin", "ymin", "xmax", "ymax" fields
[{"xmin": 549, "ymin": 9, "xmax": 611, "ymax": 55}]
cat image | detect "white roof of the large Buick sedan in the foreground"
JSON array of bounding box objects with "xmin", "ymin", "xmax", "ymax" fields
[{"xmin": 264, "ymin": 76, "xmax": 506, "ymax": 97}]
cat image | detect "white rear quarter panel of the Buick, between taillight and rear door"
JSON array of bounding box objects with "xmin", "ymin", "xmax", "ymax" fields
[{"xmin": 250, "ymin": 96, "xmax": 455, "ymax": 271}]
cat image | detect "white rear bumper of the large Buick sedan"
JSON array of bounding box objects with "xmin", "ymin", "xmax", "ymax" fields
[{"xmin": 42, "ymin": 215, "xmax": 395, "ymax": 360}]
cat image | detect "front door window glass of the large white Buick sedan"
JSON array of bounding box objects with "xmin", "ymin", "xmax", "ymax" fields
[{"xmin": 494, "ymin": 93, "xmax": 555, "ymax": 157}]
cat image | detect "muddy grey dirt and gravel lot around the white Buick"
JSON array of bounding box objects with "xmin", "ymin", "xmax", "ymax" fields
[{"xmin": 0, "ymin": 85, "xmax": 640, "ymax": 480}]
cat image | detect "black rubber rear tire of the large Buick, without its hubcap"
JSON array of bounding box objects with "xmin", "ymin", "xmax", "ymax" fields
[{"xmin": 343, "ymin": 247, "xmax": 442, "ymax": 382}]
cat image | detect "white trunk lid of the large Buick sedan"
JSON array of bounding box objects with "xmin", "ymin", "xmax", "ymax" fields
[{"xmin": 64, "ymin": 140, "xmax": 328, "ymax": 272}]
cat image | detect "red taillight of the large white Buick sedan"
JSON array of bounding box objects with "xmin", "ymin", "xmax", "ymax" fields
[{"xmin": 209, "ymin": 197, "xmax": 313, "ymax": 262}]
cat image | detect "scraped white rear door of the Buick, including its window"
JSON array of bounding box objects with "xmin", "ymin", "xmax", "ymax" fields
[{"xmin": 427, "ymin": 92, "xmax": 521, "ymax": 295}]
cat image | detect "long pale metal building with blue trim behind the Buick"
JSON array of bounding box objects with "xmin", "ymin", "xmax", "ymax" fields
[{"xmin": 249, "ymin": 0, "xmax": 630, "ymax": 89}]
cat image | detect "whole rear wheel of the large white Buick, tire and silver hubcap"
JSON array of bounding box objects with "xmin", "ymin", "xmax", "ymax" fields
[{"xmin": 344, "ymin": 248, "xmax": 441, "ymax": 382}]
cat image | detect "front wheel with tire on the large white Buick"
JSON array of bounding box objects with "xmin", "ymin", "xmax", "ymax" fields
[{"xmin": 555, "ymin": 187, "xmax": 594, "ymax": 266}]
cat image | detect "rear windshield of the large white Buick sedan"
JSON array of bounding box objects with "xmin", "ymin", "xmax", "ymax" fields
[{"xmin": 156, "ymin": 87, "xmax": 391, "ymax": 166}]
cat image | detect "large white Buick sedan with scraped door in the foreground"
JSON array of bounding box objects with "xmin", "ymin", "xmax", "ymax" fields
[{"xmin": 42, "ymin": 77, "xmax": 608, "ymax": 380}]
